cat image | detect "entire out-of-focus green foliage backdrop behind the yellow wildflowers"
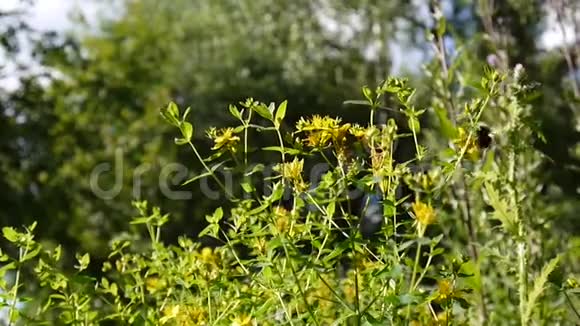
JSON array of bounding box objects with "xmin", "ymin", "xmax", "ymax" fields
[{"xmin": 0, "ymin": 0, "xmax": 580, "ymax": 324}]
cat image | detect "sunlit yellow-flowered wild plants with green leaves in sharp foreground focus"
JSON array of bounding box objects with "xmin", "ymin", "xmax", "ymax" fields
[{"xmin": 0, "ymin": 54, "xmax": 578, "ymax": 325}]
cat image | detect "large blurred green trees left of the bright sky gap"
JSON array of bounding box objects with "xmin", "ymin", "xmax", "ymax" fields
[{"xmin": 0, "ymin": 0, "xmax": 416, "ymax": 255}]
